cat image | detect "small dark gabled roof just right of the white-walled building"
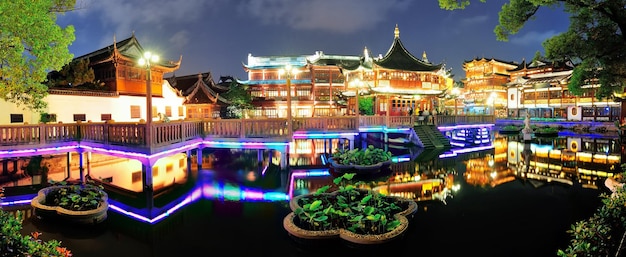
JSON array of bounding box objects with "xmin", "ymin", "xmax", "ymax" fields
[{"xmin": 166, "ymin": 72, "xmax": 230, "ymax": 104}]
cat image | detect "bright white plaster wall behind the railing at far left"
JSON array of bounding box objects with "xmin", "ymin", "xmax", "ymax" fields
[{"xmin": 0, "ymin": 80, "xmax": 185, "ymax": 125}]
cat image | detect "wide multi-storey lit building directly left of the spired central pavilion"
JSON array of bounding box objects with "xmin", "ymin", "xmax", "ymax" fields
[{"xmin": 239, "ymin": 51, "xmax": 359, "ymax": 118}]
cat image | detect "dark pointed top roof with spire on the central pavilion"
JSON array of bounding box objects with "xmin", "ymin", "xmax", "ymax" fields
[{"xmin": 373, "ymin": 25, "xmax": 442, "ymax": 71}]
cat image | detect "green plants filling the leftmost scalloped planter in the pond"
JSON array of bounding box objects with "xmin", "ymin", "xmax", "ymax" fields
[{"xmin": 44, "ymin": 180, "xmax": 105, "ymax": 211}]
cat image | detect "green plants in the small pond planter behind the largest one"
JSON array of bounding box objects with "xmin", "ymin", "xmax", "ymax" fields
[{"xmin": 333, "ymin": 145, "xmax": 392, "ymax": 165}]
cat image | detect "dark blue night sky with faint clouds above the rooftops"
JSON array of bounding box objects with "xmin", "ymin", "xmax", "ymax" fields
[{"xmin": 58, "ymin": 0, "xmax": 569, "ymax": 79}]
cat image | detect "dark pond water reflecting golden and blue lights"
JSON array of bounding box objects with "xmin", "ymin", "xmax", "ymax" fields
[{"xmin": 8, "ymin": 132, "xmax": 623, "ymax": 257}]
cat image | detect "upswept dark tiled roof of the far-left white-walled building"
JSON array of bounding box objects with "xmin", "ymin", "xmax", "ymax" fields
[{"xmin": 74, "ymin": 33, "xmax": 182, "ymax": 72}]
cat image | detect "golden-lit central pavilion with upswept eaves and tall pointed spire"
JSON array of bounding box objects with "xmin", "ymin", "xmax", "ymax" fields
[{"xmin": 342, "ymin": 25, "xmax": 453, "ymax": 116}]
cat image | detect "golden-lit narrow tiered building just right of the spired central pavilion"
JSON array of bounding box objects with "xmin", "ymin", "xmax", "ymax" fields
[{"xmin": 460, "ymin": 58, "xmax": 518, "ymax": 118}]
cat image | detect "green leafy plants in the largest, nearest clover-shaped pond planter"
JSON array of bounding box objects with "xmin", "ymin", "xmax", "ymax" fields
[{"xmin": 294, "ymin": 173, "xmax": 403, "ymax": 235}]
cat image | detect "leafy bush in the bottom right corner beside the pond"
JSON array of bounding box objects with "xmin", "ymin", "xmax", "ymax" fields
[{"xmin": 557, "ymin": 169, "xmax": 626, "ymax": 257}]
